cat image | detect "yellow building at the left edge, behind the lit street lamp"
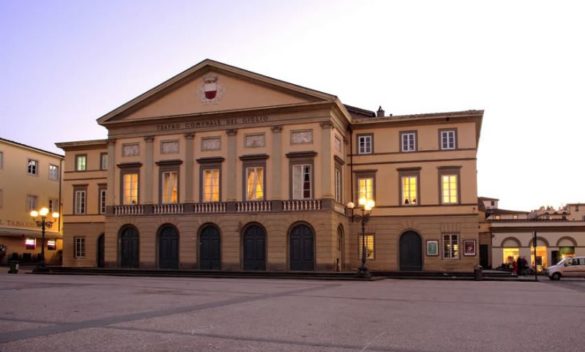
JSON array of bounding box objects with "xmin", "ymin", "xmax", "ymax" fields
[{"xmin": 0, "ymin": 138, "xmax": 63, "ymax": 264}]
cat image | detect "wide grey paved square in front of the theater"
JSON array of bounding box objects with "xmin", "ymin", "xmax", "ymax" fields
[{"xmin": 0, "ymin": 273, "xmax": 585, "ymax": 352}]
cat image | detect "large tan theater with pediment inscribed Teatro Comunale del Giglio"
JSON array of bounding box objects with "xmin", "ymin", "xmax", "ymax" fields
[{"xmin": 57, "ymin": 60, "xmax": 483, "ymax": 271}]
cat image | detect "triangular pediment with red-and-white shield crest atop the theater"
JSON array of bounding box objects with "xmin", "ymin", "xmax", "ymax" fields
[{"xmin": 98, "ymin": 60, "xmax": 337, "ymax": 125}]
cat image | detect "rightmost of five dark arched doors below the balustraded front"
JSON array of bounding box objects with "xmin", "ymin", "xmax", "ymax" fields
[{"xmin": 289, "ymin": 224, "xmax": 315, "ymax": 271}]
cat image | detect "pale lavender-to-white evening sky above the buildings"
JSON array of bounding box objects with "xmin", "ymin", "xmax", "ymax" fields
[{"xmin": 0, "ymin": 0, "xmax": 585, "ymax": 210}]
